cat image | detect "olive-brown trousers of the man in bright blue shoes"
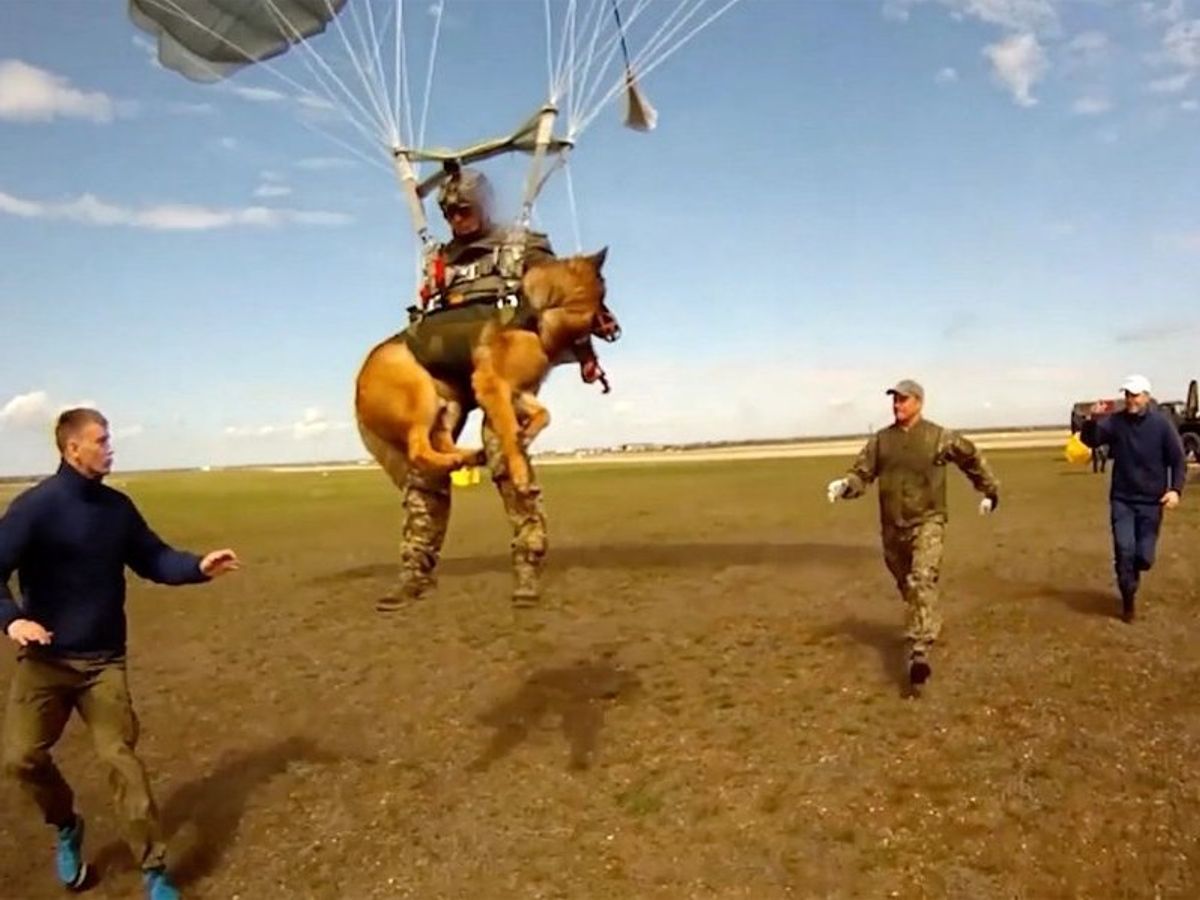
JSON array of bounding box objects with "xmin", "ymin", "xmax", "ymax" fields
[{"xmin": 4, "ymin": 649, "xmax": 167, "ymax": 869}]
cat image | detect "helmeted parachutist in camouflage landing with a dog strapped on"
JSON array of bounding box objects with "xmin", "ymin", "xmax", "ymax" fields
[{"xmin": 377, "ymin": 169, "xmax": 602, "ymax": 612}]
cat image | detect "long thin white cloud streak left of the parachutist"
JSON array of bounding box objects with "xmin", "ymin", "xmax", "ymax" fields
[{"xmin": 0, "ymin": 191, "xmax": 353, "ymax": 232}]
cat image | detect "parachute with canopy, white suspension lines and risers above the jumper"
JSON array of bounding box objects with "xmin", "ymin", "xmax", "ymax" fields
[{"xmin": 128, "ymin": 0, "xmax": 740, "ymax": 245}]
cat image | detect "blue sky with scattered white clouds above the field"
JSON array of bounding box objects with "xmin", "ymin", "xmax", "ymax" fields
[{"xmin": 0, "ymin": 0, "xmax": 1200, "ymax": 474}]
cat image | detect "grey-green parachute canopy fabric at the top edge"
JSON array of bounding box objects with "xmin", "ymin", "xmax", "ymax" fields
[{"xmin": 130, "ymin": 0, "xmax": 347, "ymax": 82}]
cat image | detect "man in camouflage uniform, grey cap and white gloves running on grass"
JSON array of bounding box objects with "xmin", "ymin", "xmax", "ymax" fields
[{"xmin": 828, "ymin": 379, "xmax": 1000, "ymax": 686}]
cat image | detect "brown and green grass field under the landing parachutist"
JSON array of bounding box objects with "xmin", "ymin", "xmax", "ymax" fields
[{"xmin": 0, "ymin": 450, "xmax": 1200, "ymax": 900}]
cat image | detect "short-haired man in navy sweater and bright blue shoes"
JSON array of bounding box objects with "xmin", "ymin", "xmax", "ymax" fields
[{"xmin": 0, "ymin": 408, "xmax": 239, "ymax": 900}]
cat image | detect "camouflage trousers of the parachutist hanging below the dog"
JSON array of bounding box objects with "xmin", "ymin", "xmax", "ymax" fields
[{"xmin": 400, "ymin": 412, "xmax": 547, "ymax": 602}]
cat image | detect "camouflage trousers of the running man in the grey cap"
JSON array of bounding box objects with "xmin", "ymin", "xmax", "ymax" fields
[{"xmin": 883, "ymin": 522, "xmax": 946, "ymax": 652}]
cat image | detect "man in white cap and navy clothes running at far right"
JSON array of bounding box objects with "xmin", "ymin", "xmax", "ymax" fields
[{"xmin": 1079, "ymin": 376, "xmax": 1187, "ymax": 622}]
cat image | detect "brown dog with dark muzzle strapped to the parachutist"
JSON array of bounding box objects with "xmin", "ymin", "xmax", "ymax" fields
[{"xmin": 354, "ymin": 250, "xmax": 616, "ymax": 490}]
